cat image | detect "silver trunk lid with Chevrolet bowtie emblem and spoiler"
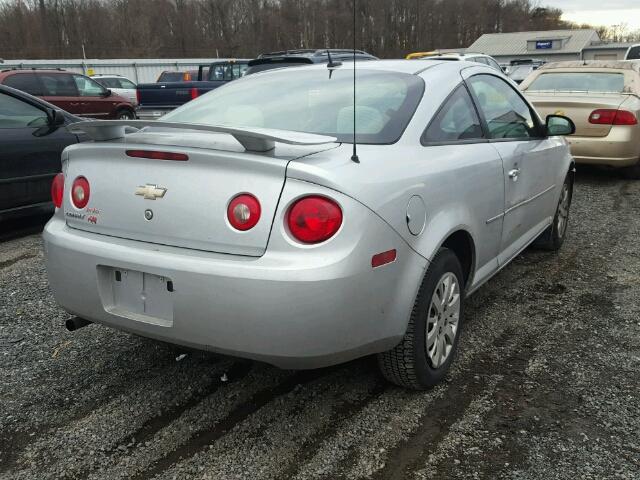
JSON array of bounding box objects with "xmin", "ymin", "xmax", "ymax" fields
[{"xmin": 63, "ymin": 127, "xmax": 332, "ymax": 256}]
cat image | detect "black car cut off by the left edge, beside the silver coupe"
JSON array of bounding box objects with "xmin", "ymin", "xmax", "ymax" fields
[{"xmin": 0, "ymin": 85, "xmax": 83, "ymax": 221}]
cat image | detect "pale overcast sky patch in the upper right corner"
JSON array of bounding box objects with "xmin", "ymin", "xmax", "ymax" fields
[{"xmin": 540, "ymin": 0, "xmax": 640, "ymax": 30}]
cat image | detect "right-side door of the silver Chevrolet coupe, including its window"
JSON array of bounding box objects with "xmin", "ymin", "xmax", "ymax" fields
[{"xmin": 466, "ymin": 71, "xmax": 560, "ymax": 264}]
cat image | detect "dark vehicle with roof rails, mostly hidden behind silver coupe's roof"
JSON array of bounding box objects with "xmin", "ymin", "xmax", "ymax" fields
[{"xmin": 245, "ymin": 48, "xmax": 378, "ymax": 75}]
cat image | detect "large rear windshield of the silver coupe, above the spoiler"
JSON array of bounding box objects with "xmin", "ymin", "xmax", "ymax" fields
[{"xmin": 163, "ymin": 68, "xmax": 424, "ymax": 144}]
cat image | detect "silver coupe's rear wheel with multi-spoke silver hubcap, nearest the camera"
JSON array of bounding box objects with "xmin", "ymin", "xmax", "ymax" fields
[{"xmin": 378, "ymin": 248, "xmax": 464, "ymax": 390}]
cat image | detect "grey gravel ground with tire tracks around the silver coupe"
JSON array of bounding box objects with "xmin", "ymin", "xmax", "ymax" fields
[{"xmin": 0, "ymin": 167, "xmax": 640, "ymax": 480}]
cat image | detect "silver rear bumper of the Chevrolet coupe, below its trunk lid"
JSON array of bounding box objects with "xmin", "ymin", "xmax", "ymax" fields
[{"xmin": 43, "ymin": 214, "xmax": 427, "ymax": 369}]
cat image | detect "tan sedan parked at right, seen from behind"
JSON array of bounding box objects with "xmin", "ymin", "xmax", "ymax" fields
[{"xmin": 520, "ymin": 61, "xmax": 640, "ymax": 178}]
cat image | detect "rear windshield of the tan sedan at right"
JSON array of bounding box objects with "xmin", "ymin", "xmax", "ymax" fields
[{"xmin": 527, "ymin": 72, "xmax": 624, "ymax": 93}]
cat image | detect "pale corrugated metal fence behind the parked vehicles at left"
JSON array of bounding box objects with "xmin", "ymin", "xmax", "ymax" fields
[{"xmin": 0, "ymin": 58, "xmax": 238, "ymax": 83}]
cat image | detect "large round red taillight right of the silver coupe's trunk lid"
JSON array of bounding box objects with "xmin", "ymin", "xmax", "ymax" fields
[{"xmin": 287, "ymin": 196, "xmax": 342, "ymax": 243}]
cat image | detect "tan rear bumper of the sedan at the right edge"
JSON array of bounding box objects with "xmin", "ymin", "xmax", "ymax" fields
[{"xmin": 567, "ymin": 126, "xmax": 640, "ymax": 167}]
